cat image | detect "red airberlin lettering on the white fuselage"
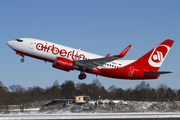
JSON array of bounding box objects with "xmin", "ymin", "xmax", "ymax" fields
[{"xmin": 35, "ymin": 43, "xmax": 85, "ymax": 60}]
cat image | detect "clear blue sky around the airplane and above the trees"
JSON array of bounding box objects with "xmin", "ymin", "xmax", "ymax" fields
[{"xmin": 0, "ymin": 0, "xmax": 180, "ymax": 89}]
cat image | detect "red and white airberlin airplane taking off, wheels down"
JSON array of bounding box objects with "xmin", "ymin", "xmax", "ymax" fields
[{"xmin": 7, "ymin": 38, "xmax": 174, "ymax": 80}]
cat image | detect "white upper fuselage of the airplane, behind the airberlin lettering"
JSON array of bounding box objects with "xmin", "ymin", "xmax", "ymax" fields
[{"xmin": 7, "ymin": 38, "xmax": 135, "ymax": 68}]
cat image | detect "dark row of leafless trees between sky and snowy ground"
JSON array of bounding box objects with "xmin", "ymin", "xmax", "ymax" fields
[{"xmin": 0, "ymin": 79, "xmax": 180, "ymax": 111}]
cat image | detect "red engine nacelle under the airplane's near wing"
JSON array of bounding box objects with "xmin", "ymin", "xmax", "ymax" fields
[{"xmin": 53, "ymin": 57, "xmax": 74, "ymax": 71}]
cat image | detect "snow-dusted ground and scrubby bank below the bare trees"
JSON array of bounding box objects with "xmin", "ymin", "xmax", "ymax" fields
[{"xmin": 0, "ymin": 101, "xmax": 180, "ymax": 120}]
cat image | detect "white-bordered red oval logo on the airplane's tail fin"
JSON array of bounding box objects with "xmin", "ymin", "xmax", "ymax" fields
[{"xmin": 148, "ymin": 45, "xmax": 170, "ymax": 67}]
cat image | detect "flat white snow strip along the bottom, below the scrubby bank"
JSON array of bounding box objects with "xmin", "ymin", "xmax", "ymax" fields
[{"xmin": 0, "ymin": 113, "xmax": 180, "ymax": 120}]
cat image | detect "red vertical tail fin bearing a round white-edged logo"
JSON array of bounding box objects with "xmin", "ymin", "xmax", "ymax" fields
[{"xmin": 128, "ymin": 39, "xmax": 174, "ymax": 71}]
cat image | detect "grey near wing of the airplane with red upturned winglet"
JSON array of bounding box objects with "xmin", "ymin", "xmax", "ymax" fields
[{"xmin": 75, "ymin": 45, "xmax": 132, "ymax": 69}]
